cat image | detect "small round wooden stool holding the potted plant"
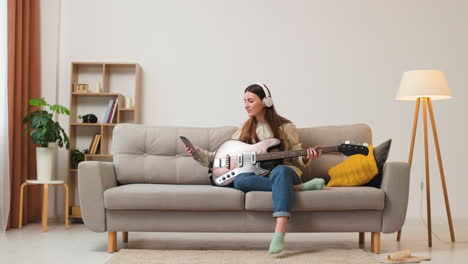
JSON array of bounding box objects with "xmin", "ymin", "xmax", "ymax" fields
[{"xmin": 18, "ymin": 180, "xmax": 68, "ymax": 232}]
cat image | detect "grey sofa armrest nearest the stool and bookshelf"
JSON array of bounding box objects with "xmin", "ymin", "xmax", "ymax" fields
[{"xmin": 78, "ymin": 161, "xmax": 117, "ymax": 232}]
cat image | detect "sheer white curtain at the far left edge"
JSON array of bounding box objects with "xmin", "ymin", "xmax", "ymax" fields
[{"xmin": 0, "ymin": 0, "xmax": 10, "ymax": 233}]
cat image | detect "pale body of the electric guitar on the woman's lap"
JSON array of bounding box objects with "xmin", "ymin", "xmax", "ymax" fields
[{"xmin": 212, "ymin": 138, "xmax": 282, "ymax": 186}]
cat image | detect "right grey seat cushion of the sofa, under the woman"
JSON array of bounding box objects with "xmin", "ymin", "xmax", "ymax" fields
[{"xmin": 245, "ymin": 186, "xmax": 385, "ymax": 211}]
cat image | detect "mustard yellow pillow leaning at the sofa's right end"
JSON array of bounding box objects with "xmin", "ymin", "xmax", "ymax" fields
[{"xmin": 327, "ymin": 145, "xmax": 379, "ymax": 186}]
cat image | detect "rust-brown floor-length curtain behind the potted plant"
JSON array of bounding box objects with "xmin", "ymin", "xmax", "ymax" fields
[{"xmin": 7, "ymin": 0, "xmax": 42, "ymax": 230}]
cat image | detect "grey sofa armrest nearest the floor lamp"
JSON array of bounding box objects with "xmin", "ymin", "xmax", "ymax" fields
[{"xmin": 380, "ymin": 162, "xmax": 410, "ymax": 233}]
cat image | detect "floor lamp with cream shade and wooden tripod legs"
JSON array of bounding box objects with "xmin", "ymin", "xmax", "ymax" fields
[{"xmin": 396, "ymin": 70, "xmax": 455, "ymax": 247}]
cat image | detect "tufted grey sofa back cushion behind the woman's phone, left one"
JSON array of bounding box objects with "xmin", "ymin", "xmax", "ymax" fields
[{"xmin": 112, "ymin": 124, "xmax": 237, "ymax": 184}]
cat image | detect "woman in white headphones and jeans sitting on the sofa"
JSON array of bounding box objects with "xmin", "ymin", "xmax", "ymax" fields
[{"xmin": 185, "ymin": 83, "xmax": 325, "ymax": 254}]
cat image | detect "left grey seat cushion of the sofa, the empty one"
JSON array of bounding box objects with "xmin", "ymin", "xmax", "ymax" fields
[{"xmin": 104, "ymin": 184, "xmax": 245, "ymax": 210}]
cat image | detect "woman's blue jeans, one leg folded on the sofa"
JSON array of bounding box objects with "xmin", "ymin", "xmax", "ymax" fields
[{"xmin": 234, "ymin": 165, "xmax": 301, "ymax": 217}]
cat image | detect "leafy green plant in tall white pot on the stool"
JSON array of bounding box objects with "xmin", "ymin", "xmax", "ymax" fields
[{"xmin": 23, "ymin": 98, "xmax": 70, "ymax": 181}]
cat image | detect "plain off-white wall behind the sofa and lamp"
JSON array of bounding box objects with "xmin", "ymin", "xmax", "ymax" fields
[{"xmin": 42, "ymin": 0, "xmax": 468, "ymax": 223}]
